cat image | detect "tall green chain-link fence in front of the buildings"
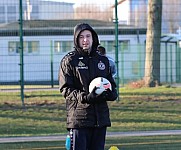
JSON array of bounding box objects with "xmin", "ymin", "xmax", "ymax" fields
[{"xmin": 0, "ymin": 0, "xmax": 181, "ymax": 89}]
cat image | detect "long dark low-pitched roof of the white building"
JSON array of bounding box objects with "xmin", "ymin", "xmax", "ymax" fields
[{"xmin": 0, "ymin": 19, "xmax": 146, "ymax": 36}]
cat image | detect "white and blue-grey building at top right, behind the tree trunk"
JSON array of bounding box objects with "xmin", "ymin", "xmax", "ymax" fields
[{"xmin": 112, "ymin": 0, "xmax": 181, "ymax": 34}]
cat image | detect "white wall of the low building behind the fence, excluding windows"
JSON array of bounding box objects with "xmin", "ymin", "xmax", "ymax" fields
[{"xmin": 0, "ymin": 32, "xmax": 176, "ymax": 82}]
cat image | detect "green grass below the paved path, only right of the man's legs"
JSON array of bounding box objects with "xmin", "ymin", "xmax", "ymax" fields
[{"xmin": 105, "ymin": 136, "xmax": 181, "ymax": 150}]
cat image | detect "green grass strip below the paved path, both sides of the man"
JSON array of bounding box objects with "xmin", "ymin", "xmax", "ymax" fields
[{"xmin": 0, "ymin": 135, "xmax": 181, "ymax": 150}]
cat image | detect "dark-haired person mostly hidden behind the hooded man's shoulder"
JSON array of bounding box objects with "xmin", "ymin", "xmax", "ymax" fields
[{"xmin": 97, "ymin": 45, "xmax": 117, "ymax": 78}]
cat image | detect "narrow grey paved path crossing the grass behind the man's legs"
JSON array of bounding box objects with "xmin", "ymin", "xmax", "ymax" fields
[{"xmin": 0, "ymin": 130, "xmax": 181, "ymax": 143}]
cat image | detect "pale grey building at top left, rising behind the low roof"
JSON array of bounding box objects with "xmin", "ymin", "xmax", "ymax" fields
[{"xmin": 0, "ymin": 0, "xmax": 74, "ymax": 24}]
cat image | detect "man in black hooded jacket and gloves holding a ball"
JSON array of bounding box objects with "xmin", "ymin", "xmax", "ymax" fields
[{"xmin": 59, "ymin": 23, "xmax": 117, "ymax": 150}]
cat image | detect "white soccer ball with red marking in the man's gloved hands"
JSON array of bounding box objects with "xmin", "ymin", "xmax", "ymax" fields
[{"xmin": 89, "ymin": 77, "xmax": 112, "ymax": 94}]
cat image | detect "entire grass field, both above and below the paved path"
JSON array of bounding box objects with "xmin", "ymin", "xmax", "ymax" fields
[{"xmin": 0, "ymin": 87, "xmax": 181, "ymax": 150}]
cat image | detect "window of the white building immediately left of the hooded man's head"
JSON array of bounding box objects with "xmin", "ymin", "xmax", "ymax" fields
[{"xmin": 54, "ymin": 41, "xmax": 73, "ymax": 53}]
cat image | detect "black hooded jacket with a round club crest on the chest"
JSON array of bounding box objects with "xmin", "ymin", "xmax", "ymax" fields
[{"xmin": 59, "ymin": 23, "xmax": 117, "ymax": 129}]
